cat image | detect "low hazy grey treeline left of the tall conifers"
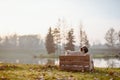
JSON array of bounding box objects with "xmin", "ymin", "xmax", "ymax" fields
[{"xmin": 0, "ymin": 34, "xmax": 45, "ymax": 49}]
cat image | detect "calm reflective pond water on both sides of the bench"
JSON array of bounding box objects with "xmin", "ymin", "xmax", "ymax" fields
[{"xmin": 0, "ymin": 58, "xmax": 120, "ymax": 68}]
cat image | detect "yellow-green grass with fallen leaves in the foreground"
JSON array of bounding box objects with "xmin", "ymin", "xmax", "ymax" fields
[{"xmin": 0, "ymin": 63, "xmax": 120, "ymax": 80}]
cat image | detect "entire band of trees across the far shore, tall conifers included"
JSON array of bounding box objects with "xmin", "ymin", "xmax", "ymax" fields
[{"xmin": 0, "ymin": 20, "xmax": 120, "ymax": 53}]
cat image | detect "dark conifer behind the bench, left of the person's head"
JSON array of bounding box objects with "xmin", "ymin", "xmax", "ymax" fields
[{"xmin": 65, "ymin": 29, "xmax": 75, "ymax": 51}]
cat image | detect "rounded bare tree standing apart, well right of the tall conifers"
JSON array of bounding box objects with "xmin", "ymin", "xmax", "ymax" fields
[{"xmin": 105, "ymin": 28, "xmax": 117, "ymax": 47}]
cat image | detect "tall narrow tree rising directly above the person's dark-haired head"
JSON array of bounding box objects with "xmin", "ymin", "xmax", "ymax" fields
[{"xmin": 80, "ymin": 24, "xmax": 90, "ymax": 47}]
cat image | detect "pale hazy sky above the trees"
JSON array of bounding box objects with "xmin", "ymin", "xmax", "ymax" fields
[{"xmin": 0, "ymin": 0, "xmax": 120, "ymax": 43}]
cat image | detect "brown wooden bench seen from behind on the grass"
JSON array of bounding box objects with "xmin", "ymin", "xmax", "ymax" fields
[{"xmin": 59, "ymin": 55, "xmax": 90, "ymax": 71}]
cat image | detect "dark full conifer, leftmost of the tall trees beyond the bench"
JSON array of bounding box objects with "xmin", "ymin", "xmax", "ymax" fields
[{"xmin": 45, "ymin": 27, "xmax": 55, "ymax": 54}]
